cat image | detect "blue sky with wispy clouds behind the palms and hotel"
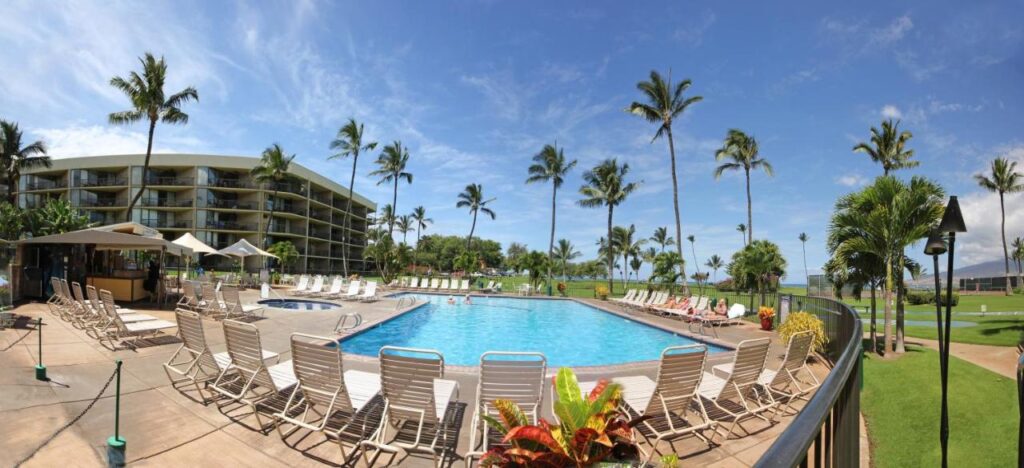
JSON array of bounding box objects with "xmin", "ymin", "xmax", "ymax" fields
[{"xmin": 0, "ymin": 1, "xmax": 1024, "ymax": 281}]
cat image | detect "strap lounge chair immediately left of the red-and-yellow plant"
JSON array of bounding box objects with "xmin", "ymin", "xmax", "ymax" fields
[{"xmin": 466, "ymin": 351, "xmax": 548, "ymax": 459}]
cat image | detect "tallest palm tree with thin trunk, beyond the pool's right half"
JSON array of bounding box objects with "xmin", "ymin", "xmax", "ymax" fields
[{"xmin": 627, "ymin": 70, "xmax": 703, "ymax": 292}]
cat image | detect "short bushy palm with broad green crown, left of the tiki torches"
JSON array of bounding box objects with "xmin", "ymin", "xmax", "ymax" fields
[{"xmin": 828, "ymin": 176, "xmax": 944, "ymax": 355}]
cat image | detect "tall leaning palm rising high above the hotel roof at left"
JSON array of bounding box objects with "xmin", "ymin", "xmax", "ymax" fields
[{"xmin": 108, "ymin": 52, "xmax": 199, "ymax": 221}]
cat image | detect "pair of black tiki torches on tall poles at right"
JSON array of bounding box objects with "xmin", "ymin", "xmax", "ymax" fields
[{"xmin": 937, "ymin": 196, "xmax": 967, "ymax": 468}]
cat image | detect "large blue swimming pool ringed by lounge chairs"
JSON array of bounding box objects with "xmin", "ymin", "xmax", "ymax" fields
[{"xmin": 341, "ymin": 293, "xmax": 725, "ymax": 367}]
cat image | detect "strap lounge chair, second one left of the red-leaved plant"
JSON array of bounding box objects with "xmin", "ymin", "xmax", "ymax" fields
[{"xmin": 362, "ymin": 346, "xmax": 459, "ymax": 466}]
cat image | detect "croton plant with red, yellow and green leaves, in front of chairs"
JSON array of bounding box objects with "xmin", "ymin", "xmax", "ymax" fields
[{"xmin": 480, "ymin": 368, "xmax": 643, "ymax": 467}]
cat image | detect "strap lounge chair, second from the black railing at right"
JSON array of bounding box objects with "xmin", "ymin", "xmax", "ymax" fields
[{"xmin": 698, "ymin": 338, "xmax": 777, "ymax": 438}]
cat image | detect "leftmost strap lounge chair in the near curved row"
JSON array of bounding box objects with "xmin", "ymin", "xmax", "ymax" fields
[{"xmin": 164, "ymin": 308, "xmax": 279, "ymax": 405}]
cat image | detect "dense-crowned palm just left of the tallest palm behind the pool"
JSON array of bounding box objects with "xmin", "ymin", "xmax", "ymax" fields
[{"xmin": 577, "ymin": 159, "xmax": 634, "ymax": 294}]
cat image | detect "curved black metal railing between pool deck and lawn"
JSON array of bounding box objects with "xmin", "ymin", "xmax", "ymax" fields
[{"xmin": 756, "ymin": 295, "xmax": 863, "ymax": 467}]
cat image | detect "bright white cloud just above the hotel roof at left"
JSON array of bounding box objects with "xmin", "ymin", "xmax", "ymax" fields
[{"xmin": 32, "ymin": 125, "xmax": 203, "ymax": 159}]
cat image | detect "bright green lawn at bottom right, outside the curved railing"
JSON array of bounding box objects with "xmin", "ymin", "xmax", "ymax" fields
[{"xmin": 861, "ymin": 346, "xmax": 1018, "ymax": 467}]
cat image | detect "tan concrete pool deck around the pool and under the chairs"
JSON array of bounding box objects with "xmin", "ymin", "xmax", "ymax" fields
[{"xmin": 0, "ymin": 291, "xmax": 827, "ymax": 467}]
